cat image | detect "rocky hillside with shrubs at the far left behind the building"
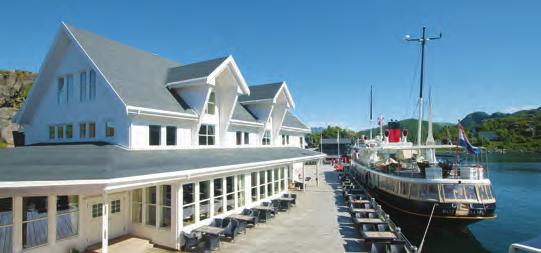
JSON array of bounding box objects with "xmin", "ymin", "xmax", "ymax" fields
[{"xmin": 0, "ymin": 70, "xmax": 36, "ymax": 148}]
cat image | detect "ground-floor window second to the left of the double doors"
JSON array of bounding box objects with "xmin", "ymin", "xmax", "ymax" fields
[{"xmin": 22, "ymin": 197, "xmax": 49, "ymax": 249}]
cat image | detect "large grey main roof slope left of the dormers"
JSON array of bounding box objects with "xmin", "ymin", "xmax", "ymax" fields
[{"xmin": 65, "ymin": 25, "xmax": 194, "ymax": 114}]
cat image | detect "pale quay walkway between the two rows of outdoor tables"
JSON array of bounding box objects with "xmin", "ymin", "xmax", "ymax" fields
[{"xmin": 218, "ymin": 165, "xmax": 363, "ymax": 253}]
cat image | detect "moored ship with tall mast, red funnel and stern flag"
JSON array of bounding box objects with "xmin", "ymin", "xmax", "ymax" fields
[{"xmin": 348, "ymin": 27, "xmax": 496, "ymax": 224}]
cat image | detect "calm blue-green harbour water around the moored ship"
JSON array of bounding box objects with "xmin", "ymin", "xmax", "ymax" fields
[{"xmin": 393, "ymin": 154, "xmax": 541, "ymax": 253}]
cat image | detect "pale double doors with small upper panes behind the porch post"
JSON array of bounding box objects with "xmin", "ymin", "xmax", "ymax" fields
[{"xmin": 87, "ymin": 195, "xmax": 128, "ymax": 244}]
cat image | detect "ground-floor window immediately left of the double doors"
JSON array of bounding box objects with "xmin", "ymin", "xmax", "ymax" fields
[{"xmin": 56, "ymin": 195, "xmax": 79, "ymax": 240}]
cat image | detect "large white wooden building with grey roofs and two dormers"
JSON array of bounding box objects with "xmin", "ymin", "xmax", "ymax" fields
[{"xmin": 0, "ymin": 24, "xmax": 324, "ymax": 253}]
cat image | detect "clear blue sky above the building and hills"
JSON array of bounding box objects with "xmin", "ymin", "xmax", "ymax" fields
[{"xmin": 0, "ymin": 0, "xmax": 541, "ymax": 129}]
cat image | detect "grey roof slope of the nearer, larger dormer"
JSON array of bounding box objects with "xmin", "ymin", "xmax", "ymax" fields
[{"xmin": 166, "ymin": 56, "xmax": 227, "ymax": 83}]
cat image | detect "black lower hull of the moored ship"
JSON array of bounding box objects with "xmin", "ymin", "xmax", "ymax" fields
[{"xmin": 364, "ymin": 185, "xmax": 496, "ymax": 226}]
